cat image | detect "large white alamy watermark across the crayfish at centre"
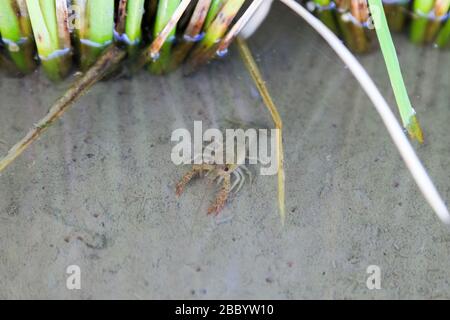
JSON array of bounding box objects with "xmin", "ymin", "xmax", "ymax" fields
[{"xmin": 171, "ymin": 121, "xmax": 278, "ymax": 176}]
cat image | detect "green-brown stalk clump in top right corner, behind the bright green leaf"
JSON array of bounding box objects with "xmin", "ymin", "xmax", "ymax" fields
[{"xmin": 309, "ymin": 0, "xmax": 450, "ymax": 49}]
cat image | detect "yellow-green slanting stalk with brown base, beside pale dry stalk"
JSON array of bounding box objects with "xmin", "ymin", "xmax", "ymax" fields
[{"xmin": 186, "ymin": 0, "xmax": 245, "ymax": 73}]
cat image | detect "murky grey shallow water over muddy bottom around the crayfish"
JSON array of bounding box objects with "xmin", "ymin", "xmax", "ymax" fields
[{"xmin": 0, "ymin": 1, "xmax": 450, "ymax": 298}]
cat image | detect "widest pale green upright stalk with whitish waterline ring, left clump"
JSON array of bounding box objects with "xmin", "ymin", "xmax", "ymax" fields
[{"xmin": 73, "ymin": 0, "xmax": 114, "ymax": 71}]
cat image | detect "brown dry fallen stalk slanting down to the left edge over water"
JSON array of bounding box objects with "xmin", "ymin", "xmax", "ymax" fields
[{"xmin": 0, "ymin": 45, "xmax": 126, "ymax": 173}]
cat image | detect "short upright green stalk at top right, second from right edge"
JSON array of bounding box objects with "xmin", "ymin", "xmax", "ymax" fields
[{"xmin": 410, "ymin": 0, "xmax": 435, "ymax": 44}]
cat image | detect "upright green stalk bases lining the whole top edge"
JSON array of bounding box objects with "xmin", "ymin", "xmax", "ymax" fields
[{"xmin": 0, "ymin": 0, "xmax": 450, "ymax": 81}]
